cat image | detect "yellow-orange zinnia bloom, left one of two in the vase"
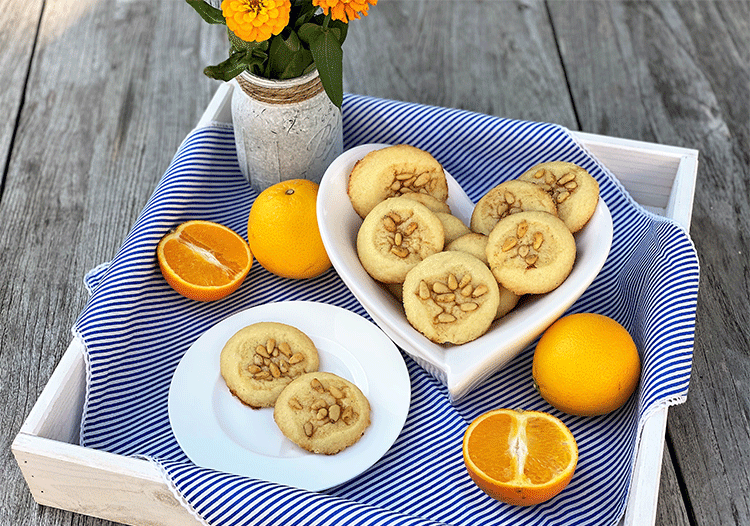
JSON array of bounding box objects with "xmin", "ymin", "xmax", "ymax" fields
[{"xmin": 221, "ymin": 0, "xmax": 292, "ymax": 42}]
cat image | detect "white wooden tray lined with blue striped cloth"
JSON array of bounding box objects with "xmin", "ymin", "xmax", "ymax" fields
[{"xmin": 12, "ymin": 82, "xmax": 698, "ymax": 526}]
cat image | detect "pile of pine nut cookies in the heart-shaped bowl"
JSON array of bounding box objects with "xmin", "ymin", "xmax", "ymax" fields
[{"xmin": 348, "ymin": 145, "xmax": 599, "ymax": 345}]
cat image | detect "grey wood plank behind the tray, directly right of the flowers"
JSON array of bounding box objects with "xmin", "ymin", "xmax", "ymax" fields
[{"xmin": 344, "ymin": 0, "xmax": 576, "ymax": 129}]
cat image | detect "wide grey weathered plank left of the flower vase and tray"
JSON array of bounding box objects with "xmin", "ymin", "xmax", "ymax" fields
[{"xmin": 0, "ymin": 0, "xmax": 226, "ymax": 525}]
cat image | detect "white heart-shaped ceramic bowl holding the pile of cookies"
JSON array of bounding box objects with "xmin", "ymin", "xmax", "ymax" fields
[{"xmin": 317, "ymin": 144, "xmax": 612, "ymax": 400}]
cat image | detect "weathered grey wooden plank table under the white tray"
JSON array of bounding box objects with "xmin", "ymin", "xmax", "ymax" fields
[{"xmin": 0, "ymin": 0, "xmax": 750, "ymax": 526}]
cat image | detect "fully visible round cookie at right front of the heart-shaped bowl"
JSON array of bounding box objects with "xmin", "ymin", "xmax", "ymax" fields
[{"xmin": 487, "ymin": 212, "xmax": 576, "ymax": 295}]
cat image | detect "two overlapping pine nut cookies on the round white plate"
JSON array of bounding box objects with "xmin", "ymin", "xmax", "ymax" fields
[{"xmin": 220, "ymin": 322, "xmax": 370, "ymax": 455}]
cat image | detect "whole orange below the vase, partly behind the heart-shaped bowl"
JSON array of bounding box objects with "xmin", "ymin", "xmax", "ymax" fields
[{"xmin": 247, "ymin": 179, "xmax": 331, "ymax": 279}]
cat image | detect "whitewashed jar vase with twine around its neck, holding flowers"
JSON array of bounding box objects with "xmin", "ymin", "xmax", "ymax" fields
[{"xmin": 232, "ymin": 70, "xmax": 343, "ymax": 192}]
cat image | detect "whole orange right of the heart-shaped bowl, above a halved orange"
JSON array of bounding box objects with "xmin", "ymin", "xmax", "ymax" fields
[{"xmin": 532, "ymin": 313, "xmax": 641, "ymax": 416}]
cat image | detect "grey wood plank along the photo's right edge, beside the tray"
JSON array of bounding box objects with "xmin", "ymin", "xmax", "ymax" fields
[{"xmin": 549, "ymin": 1, "xmax": 750, "ymax": 525}]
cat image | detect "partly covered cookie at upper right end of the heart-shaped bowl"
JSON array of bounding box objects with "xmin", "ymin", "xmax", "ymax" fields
[{"xmin": 519, "ymin": 161, "xmax": 599, "ymax": 232}]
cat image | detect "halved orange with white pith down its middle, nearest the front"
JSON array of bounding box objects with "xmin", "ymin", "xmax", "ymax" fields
[{"xmin": 463, "ymin": 409, "xmax": 578, "ymax": 506}]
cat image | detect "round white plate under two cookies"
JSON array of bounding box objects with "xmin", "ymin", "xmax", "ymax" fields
[{"xmin": 168, "ymin": 301, "xmax": 411, "ymax": 491}]
